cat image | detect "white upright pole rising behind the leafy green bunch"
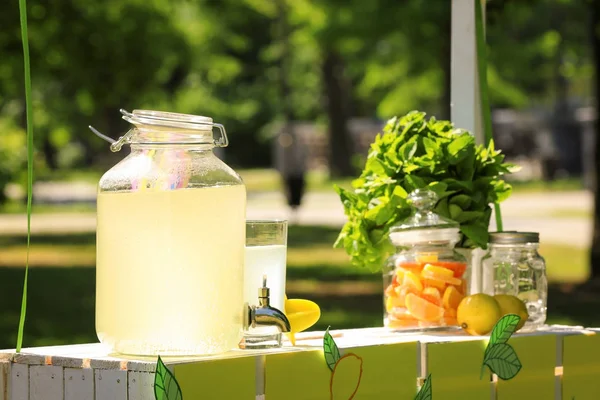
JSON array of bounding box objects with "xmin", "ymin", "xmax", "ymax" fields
[{"xmin": 450, "ymin": 0, "xmax": 485, "ymax": 143}]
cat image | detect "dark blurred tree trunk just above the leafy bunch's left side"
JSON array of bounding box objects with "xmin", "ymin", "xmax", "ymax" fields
[{"xmin": 322, "ymin": 48, "xmax": 354, "ymax": 177}]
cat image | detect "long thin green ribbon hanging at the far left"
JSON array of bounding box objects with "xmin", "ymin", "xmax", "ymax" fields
[{"xmin": 16, "ymin": 0, "xmax": 33, "ymax": 353}]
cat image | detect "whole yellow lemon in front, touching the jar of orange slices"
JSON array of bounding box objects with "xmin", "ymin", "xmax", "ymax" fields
[{"xmin": 456, "ymin": 293, "xmax": 502, "ymax": 335}]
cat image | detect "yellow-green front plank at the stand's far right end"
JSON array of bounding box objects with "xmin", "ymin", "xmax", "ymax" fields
[{"xmin": 562, "ymin": 335, "xmax": 600, "ymax": 400}]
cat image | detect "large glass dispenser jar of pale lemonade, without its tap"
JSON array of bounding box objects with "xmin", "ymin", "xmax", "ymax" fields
[{"xmin": 96, "ymin": 110, "xmax": 245, "ymax": 355}]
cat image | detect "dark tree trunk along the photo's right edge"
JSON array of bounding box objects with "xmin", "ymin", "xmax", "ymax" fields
[{"xmin": 590, "ymin": 0, "xmax": 600, "ymax": 280}]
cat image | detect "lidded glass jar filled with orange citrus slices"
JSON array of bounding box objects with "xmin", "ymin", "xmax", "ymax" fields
[{"xmin": 383, "ymin": 189, "xmax": 470, "ymax": 331}]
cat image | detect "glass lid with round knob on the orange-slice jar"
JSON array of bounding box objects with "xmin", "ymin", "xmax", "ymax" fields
[{"xmin": 390, "ymin": 189, "xmax": 460, "ymax": 246}]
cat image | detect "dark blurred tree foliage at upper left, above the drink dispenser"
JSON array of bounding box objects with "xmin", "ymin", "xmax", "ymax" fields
[{"xmin": 0, "ymin": 0, "xmax": 190, "ymax": 168}]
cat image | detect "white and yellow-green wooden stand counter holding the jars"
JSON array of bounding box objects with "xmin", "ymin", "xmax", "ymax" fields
[{"xmin": 0, "ymin": 326, "xmax": 600, "ymax": 400}]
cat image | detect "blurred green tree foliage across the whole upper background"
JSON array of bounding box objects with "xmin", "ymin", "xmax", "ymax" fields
[{"xmin": 0, "ymin": 0, "xmax": 593, "ymax": 189}]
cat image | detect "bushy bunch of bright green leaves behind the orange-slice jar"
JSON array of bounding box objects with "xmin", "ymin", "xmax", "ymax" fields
[{"xmin": 335, "ymin": 111, "xmax": 514, "ymax": 271}]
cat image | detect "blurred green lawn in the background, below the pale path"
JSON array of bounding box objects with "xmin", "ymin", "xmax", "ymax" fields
[{"xmin": 0, "ymin": 226, "xmax": 600, "ymax": 348}]
